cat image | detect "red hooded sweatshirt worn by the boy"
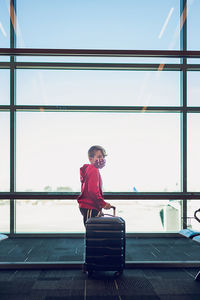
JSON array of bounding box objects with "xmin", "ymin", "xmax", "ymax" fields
[{"xmin": 77, "ymin": 164, "xmax": 106, "ymax": 211}]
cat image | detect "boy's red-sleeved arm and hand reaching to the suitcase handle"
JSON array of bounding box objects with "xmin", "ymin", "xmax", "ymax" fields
[{"xmin": 88, "ymin": 169, "xmax": 110, "ymax": 209}]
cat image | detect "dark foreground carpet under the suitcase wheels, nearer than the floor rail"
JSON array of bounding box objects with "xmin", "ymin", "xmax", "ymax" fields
[{"xmin": 0, "ymin": 269, "xmax": 200, "ymax": 300}]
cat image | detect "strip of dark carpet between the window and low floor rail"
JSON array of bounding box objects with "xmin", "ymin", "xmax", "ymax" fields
[{"xmin": 0, "ymin": 236, "xmax": 200, "ymax": 262}]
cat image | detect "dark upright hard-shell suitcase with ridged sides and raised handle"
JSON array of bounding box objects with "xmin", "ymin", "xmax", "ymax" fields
[{"xmin": 84, "ymin": 207, "xmax": 126, "ymax": 276}]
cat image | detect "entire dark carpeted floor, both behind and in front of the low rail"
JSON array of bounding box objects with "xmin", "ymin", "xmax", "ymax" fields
[{"xmin": 0, "ymin": 236, "xmax": 200, "ymax": 300}]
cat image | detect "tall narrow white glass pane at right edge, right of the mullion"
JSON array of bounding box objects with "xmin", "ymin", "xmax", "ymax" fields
[{"xmin": 187, "ymin": 114, "xmax": 200, "ymax": 192}]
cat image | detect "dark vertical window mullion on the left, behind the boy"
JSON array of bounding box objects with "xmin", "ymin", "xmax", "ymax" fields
[{"xmin": 10, "ymin": 0, "xmax": 16, "ymax": 236}]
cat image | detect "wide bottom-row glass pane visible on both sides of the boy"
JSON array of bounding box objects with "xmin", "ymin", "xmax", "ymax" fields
[{"xmin": 16, "ymin": 200, "xmax": 181, "ymax": 233}]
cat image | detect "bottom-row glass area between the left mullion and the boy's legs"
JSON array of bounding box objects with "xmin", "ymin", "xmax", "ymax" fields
[{"xmin": 16, "ymin": 200, "xmax": 85, "ymax": 233}]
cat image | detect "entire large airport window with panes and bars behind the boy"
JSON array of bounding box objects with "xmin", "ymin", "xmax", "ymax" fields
[{"xmin": 0, "ymin": 0, "xmax": 200, "ymax": 238}]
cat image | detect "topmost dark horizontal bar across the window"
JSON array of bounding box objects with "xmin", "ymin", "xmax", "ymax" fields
[{"xmin": 0, "ymin": 48, "xmax": 200, "ymax": 58}]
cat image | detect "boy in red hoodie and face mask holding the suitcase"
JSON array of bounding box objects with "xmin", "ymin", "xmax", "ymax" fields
[{"xmin": 77, "ymin": 146, "xmax": 111, "ymax": 225}]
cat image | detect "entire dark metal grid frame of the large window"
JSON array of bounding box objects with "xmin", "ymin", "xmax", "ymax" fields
[{"xmin": 0, "ymin": 0, "xmax": 200, "ymax": 241}]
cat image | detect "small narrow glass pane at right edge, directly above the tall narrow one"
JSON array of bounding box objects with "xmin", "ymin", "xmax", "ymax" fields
[{"xmin": 187, "ymin": 71, "xmax": 200, "ymax": 106}]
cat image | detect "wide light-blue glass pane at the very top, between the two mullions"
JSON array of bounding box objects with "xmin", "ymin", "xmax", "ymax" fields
[{"xmin": 17, "ymin": 0, "xmax": 180, "ymax": 50}]
